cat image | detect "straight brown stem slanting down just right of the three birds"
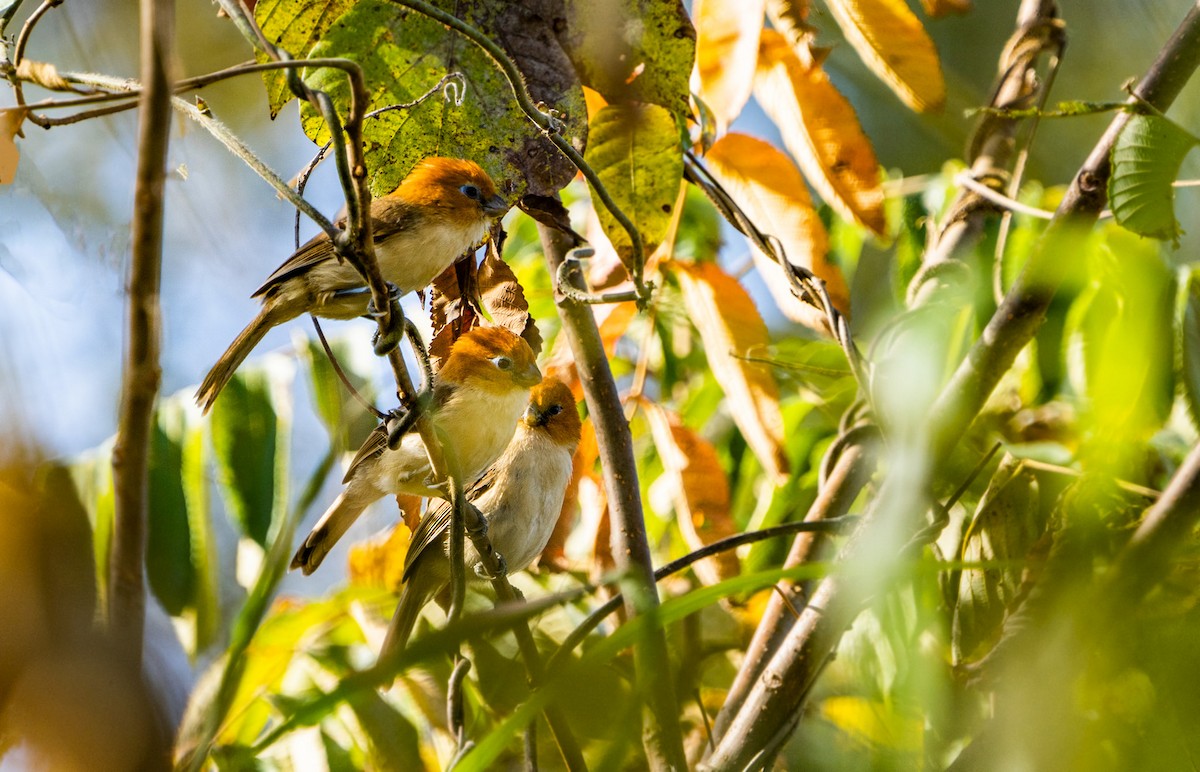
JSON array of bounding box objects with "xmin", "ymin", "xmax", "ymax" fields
[{"xmin": 538, "ymin": 222, "xmax": 686, "ymax": 770}]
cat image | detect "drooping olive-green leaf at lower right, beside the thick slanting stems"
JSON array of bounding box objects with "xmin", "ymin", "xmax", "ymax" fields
[{"xmin": 952, "ymin": 456, "xmax": 1045, "ymax": 663}]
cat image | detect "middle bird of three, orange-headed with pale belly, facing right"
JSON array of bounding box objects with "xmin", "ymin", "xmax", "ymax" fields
[{"xmin": 292, "ymin": 327, "xmax": 541, "ymax": 574}]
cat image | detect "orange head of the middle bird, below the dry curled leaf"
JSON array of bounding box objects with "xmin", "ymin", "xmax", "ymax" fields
[{"xmin": 438, "ymin": 327, "xmax": 541, "ymax": 394}]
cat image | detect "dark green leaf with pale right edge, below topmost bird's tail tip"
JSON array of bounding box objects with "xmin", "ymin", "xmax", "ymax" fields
[{"xmin": 210, "ymin": 369, "xmax": 292, "ymax": 547}]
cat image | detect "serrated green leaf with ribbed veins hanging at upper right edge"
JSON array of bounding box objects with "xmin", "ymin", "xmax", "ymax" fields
[{"xmin": 1109, "ymin": 115, "xmax": 1200, "ymax": 241}]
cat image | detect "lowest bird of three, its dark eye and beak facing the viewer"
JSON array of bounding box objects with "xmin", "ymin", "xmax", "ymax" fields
[{"xmin": 379, "ymin": 377, "xmax": 581, "ymax": 658}]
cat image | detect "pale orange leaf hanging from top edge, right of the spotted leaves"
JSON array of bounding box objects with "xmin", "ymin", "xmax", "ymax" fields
[{"xmin": 691, "ymin": 0, "xmax": 766, "ymax": 131}]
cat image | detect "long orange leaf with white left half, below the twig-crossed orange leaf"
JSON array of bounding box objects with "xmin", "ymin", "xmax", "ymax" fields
[{"xmin": 673, "ymin": 263, "xmax": 788, "ymax": 484}]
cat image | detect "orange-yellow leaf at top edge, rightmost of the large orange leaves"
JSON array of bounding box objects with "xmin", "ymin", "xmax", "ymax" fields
[{"xmin": 827, "ymin": 0, "xmax": 946, "ymax": 113}]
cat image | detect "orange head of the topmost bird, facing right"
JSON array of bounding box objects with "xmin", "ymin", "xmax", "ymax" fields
[{"xmin": 395, "ymin": 157, "xmax": 509, "ymax": 220}]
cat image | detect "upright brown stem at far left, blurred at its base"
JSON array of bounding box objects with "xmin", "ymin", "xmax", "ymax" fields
[{"xmin": 108, "ymin": 0, "xmax": 175, "ymax": 663}]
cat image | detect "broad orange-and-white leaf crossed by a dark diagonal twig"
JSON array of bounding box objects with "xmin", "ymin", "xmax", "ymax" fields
[{"xmin": 704, "ymin": 133, "xmax": 850, "ymax": 331}]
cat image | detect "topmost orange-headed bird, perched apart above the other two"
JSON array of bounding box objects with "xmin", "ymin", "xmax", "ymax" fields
[{"xmin": 196, "ymin": 157, "xmax": 509, "ymax": 413}]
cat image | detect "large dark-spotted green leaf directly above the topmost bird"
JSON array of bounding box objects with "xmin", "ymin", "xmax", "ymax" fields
[{"xmin": 300, "ymin": 0, "xmax": 587, "ymax": 197}]
